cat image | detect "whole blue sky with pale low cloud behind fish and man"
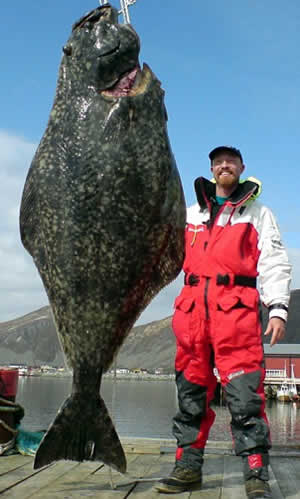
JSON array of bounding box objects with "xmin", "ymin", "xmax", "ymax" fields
[{"xmin": 0, "ymin": 0, "xmax": 300, "ymax": 322}]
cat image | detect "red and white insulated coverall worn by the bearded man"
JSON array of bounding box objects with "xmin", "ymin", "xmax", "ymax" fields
[{"xmin": 172, "ymin": 177, "xmax": 291, "ymax": 479}]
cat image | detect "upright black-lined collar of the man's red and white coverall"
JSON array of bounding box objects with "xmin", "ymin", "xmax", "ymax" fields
[{"xmin": 195, "ymin": 177, "xmax": 261, "ymax": 209}]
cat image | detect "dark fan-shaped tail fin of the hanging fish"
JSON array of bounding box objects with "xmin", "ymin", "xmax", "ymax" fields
[{"xmin": 33, "ymin": 394, "xmax": 126, "ymax": 473}]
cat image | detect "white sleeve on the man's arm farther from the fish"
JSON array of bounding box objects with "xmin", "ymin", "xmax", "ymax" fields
[{"xmin": 257, "ymin": 206, "xmax": 292, "ymax": 321}]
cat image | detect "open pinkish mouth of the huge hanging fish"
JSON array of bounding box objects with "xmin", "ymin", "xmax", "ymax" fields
[{"xmin": 100, "ymin": 63, "xmax": 153, "ymax": 99}]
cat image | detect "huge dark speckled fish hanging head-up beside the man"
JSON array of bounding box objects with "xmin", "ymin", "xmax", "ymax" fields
[{"xmin": 20, "ymin": 4, "xmax": 186, "ymax": 472}]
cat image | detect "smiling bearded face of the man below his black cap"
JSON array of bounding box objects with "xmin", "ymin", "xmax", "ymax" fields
[{"xmin": 210, "ymin": 152, "xmax": 245, "ymax": 188}]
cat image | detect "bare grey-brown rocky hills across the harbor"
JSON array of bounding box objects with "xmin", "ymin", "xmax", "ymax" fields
[{"xmin": 0, "ymin": 289, "xmax": 300, "ymax": 371}]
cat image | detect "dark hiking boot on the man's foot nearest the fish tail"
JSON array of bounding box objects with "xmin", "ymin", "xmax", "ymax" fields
[{"xmin": 154, "ymin": 465, "xmax": 202, "ymax": 494}]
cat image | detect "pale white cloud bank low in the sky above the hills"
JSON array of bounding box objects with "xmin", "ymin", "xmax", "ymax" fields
[{"xmin": 0, "ymin": 130, "xmax": 300, "ymax": 324}]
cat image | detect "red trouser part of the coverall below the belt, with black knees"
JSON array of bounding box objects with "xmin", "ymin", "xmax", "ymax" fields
[{"xmin": 172, "ymin": 287, "xmax": 271, "ymax": 468}]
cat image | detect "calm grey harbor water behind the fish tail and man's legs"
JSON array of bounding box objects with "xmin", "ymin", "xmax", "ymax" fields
[{"xmin": 16, "ymin": 376, "xmax": 300, "ymax": 445}]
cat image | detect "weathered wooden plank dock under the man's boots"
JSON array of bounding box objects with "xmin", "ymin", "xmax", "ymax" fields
[{"xmin": 0, "ymin": 438, "xmax": 300, "ymax": 499}]
